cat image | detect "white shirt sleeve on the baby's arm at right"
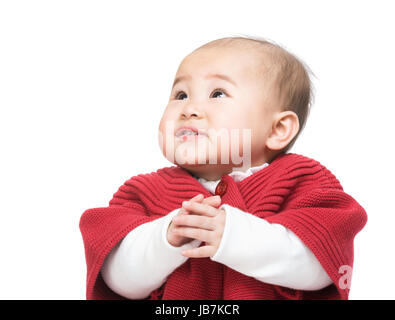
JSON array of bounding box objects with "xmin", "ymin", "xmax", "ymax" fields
[{"xmin": 211, "ymin": 204, "xmax": 332, "ymax": 290}]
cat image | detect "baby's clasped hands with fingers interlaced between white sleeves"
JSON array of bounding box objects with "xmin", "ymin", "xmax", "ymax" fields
[{"xmin": 167, "ymin": 194, "xmax": 226, "ymax": 258}]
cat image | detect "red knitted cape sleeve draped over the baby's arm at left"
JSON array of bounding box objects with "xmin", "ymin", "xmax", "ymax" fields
[{"xmin": 80, "ymin": 182, "xmax": 160, "ymax": 300}]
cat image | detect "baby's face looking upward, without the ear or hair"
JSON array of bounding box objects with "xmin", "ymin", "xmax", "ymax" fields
[{"xmin": 159, "ymin": 47, "xmax": 278, "ymax": 180}]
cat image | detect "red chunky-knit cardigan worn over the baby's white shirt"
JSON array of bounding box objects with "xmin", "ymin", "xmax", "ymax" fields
[{"xmin": 80, "ymin": 153, "xmax": 367, "ymax": 300}]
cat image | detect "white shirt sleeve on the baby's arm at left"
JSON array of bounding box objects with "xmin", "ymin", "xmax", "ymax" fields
[{"xmin": 101, "ymin": 208, "xmax": 201, "ymax": 299}]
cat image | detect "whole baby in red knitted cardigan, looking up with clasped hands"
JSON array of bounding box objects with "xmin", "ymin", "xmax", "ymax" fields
[{"xmin": 80, "ymin": 37, "xmax": 367, "ymax": 300}]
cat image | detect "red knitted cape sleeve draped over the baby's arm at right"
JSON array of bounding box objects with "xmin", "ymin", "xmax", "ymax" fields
[{"xmin": 266, "ymin": 188, "xmax": 367, "ymax": 299}]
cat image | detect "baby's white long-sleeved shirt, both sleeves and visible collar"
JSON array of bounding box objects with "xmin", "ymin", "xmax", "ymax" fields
[{"xmin": 101, "ymin": 163, "xmax": 332, "ymax": 299}]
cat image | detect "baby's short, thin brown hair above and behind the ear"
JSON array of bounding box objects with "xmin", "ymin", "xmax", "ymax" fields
[{"xmin": 195, "ymin": 36, "xmax": 314, "ymax": 153}]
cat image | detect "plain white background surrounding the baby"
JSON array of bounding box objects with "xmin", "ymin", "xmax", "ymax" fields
[{"xmin": 0, "ymin": 0, "xmax": 395, "ymax": 299}]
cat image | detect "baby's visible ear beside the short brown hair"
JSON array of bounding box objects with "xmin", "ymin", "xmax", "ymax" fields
[{"xmin": 266, "ymin": 111, "xmax": 299, "ymax": 150}]
